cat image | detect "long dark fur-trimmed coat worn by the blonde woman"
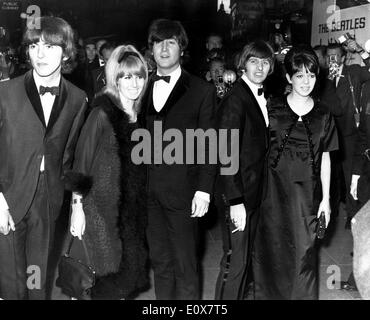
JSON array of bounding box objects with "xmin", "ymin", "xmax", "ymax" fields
[{"xmin": 66, "ymin": 94, "xmax": 148, "ymax": 299}]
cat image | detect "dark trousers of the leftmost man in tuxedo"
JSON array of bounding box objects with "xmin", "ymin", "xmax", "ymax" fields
[{"xmin": 0, "ymin": 173, "xmax": 55, "ymax": 300}]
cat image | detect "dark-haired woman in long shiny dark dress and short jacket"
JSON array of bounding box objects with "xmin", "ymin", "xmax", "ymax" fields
[{"xmin": 253, "ymin": 47, "xmax": 338, "ymax": 300}]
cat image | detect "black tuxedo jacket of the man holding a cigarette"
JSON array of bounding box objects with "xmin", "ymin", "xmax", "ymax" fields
[{"xmin": 217, "ymin": 78, "xmax": 270, "ymax": 210}]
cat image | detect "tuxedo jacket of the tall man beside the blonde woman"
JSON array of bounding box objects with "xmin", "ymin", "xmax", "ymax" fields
[{"xmin": 142, "ymin": 69, "xmax": 217, "ymax": 201}]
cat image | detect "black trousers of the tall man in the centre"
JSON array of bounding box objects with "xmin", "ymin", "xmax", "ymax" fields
[{"xmin": 147, "ymin": 178, "xmax": 200, "ymax": 300}]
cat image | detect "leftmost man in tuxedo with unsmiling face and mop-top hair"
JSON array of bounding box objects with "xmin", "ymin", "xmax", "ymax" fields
[{"xmin": 0, "ymin": 17, "xmax": 86, "ymax": 300}]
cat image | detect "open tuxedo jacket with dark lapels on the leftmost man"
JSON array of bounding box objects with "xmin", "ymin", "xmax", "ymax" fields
[{"xmin": 0, "ymin": 70, "xmax": 86, "ymax": 223}]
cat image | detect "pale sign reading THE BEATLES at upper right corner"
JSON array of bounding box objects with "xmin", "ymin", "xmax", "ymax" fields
[{"xmin": 311, "ymin": 0, "xmax": 370, "ymax": 46}]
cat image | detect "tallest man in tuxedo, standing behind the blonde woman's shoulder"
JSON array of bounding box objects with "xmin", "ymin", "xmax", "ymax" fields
[{"xmin": 143, "ymin": 19, "xmax": 216, "ymax": 300}]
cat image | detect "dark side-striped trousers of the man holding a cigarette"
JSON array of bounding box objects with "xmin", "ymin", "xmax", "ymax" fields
[{"xmin": 215, "ymin": 202, "xmax": 258, "ymax": 300}]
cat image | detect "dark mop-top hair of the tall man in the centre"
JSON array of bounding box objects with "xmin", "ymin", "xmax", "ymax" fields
[{"xmin": 148, "ymin": 19, "xmax": 189, "ymax": 51}]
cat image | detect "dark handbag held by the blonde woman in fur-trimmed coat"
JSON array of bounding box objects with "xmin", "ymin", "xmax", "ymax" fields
[{"xmin": 56, "ymin": 237, "xmax": 95, "ymax": 300}]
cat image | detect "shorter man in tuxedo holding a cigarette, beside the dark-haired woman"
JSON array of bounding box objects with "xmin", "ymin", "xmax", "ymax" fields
[{"xmin": 215, "ymin": 41, "xmax": 274, "ymax": 300}]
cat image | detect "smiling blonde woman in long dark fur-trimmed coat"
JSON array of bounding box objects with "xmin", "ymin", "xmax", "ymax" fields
[{"xmin": 67, "ymin": 45, "xmax": 148, "ymax": 299}]
